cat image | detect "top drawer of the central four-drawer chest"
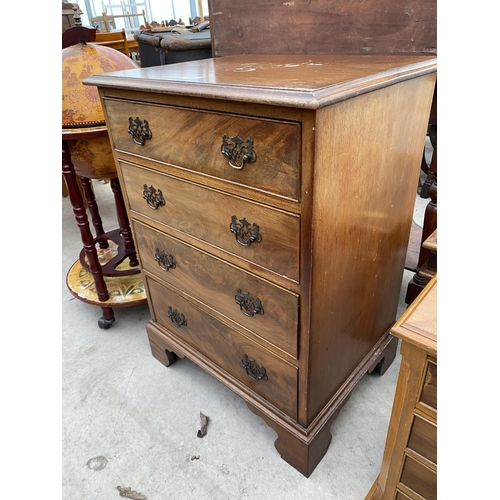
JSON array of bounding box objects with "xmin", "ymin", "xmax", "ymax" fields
[{"xmin": 104, "ymin": 99, "xmax": 300, "ymax": 200}]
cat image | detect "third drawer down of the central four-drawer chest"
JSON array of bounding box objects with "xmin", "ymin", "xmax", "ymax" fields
[{"xmin": 133, "ymin": 221, "xmax": 298, "ymax": 358}]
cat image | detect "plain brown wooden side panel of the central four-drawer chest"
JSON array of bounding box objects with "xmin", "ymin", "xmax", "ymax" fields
[{"xmin": 302, "ymin": 75, "xmax": 434, "ymax": 418}]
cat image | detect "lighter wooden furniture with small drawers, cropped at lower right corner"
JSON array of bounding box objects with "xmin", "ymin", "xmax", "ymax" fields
[{"xmin": 366, "ymin": 275, "xmax": 437, "ymax": 500}]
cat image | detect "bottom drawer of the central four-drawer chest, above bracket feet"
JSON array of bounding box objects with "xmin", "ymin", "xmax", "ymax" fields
[{"xmin": 146, "ymin": 277, "xmax": 297, "ymax": 420}]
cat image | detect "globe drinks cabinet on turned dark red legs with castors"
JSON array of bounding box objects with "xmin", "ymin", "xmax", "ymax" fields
[{"xmin": 62, "ymin": 26, "xmax": 146, "ymax": 329}]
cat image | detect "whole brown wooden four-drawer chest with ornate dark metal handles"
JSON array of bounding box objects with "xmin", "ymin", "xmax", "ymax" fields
[{"xmin": 86, "ymin": 55, "xmax": 436, "ymax": 476}]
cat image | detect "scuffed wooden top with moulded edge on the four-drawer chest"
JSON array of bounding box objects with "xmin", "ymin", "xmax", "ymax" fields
[{"xmin": 85, "ymin": 54, "xmax": 437, "ymax": 109}]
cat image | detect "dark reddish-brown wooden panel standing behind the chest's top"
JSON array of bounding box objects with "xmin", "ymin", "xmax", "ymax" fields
[{"xmin": 208, "ymin": 0, "xmax": 437, "ymax": 57}]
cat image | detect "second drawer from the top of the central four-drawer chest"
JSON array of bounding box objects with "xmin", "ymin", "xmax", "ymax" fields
[{"xmin": 120, "ymin": 162, "xmax": 300, "ymax": 282}]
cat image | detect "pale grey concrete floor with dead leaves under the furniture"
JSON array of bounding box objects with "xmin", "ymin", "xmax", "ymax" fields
[{"xmin": 62, "ymin": 178, "xmax": 428, "ymax": 500}]
